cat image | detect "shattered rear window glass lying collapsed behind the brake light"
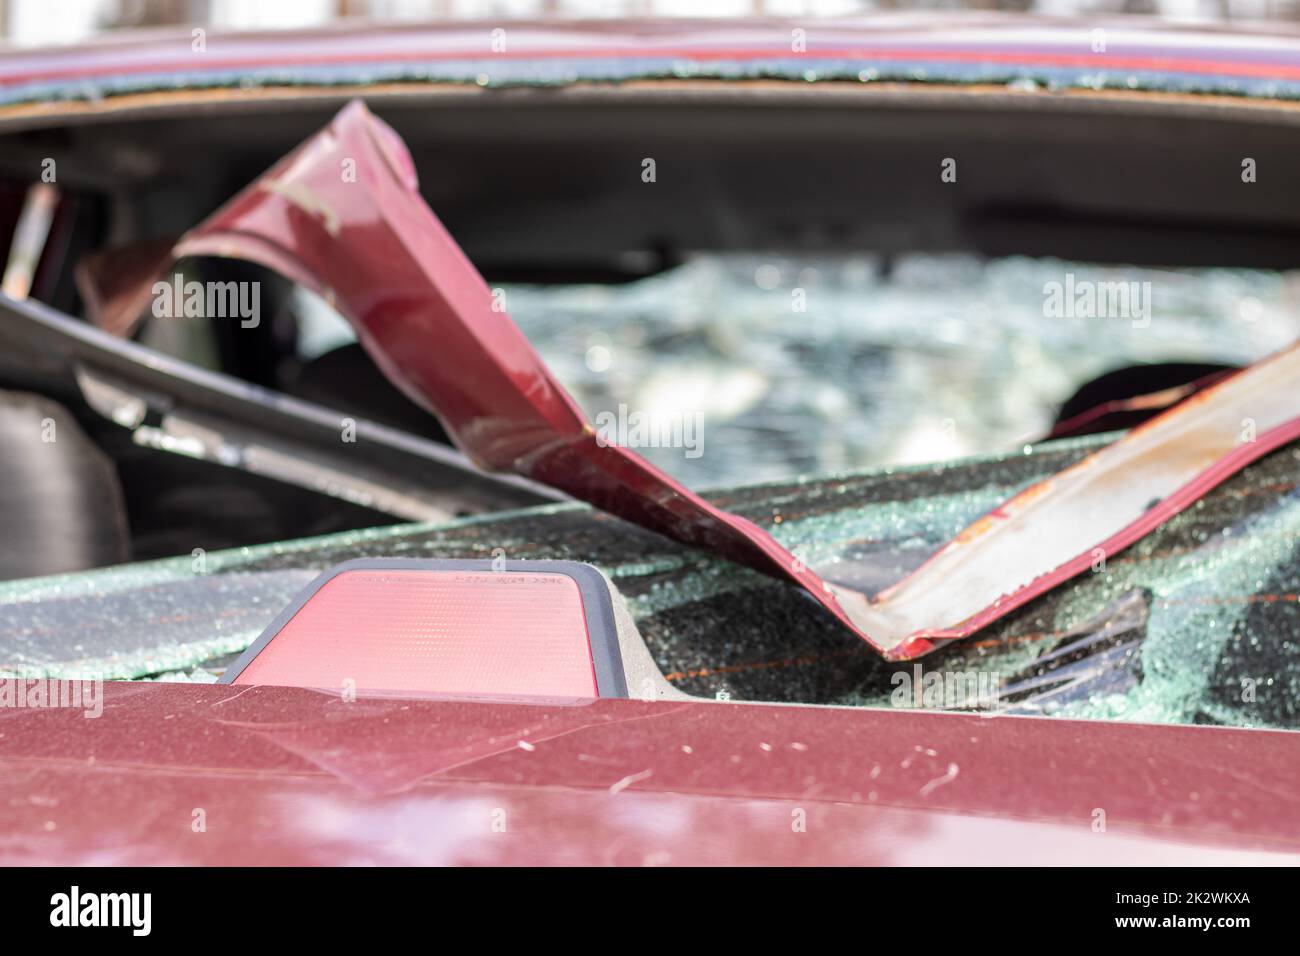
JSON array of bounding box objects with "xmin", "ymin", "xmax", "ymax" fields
[{"xmin": 0, "ymin": 436, "xmax": 1300, "ymax": 728}]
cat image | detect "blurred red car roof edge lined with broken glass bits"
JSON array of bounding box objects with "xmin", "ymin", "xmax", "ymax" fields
[{"xmin": 0, "ymin": 13, "xmax": 1300, "ymax": 105}]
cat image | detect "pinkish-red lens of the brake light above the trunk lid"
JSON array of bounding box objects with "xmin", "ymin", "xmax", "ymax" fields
[{"xmin": 234, "ymin": 571, "xmax": 598, "ymax": 697}]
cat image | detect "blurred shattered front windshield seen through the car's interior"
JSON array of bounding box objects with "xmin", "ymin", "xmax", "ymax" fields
[{"xmin": 504, "ymin": 254, "xmax": 1300, "ymax": 488}]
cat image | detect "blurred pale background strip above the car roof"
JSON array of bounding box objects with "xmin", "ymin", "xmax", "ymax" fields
[{"xmin": 0, "ymin": 0, "xmax": 1300, "ymax": 46}]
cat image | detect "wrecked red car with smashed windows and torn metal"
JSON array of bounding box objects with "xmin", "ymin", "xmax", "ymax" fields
[{"xmin": 0, "ymin": 7, "xmax": 1300, "ymax": 884}]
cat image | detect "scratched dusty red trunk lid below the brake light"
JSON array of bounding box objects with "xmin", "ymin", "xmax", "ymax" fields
[{"xmin": 0, "ymin": 684, "xmax": 1300, "ymax": 865}]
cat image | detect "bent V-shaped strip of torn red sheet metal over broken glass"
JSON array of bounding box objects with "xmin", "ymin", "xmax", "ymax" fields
[{"xmin": 86, "ymin": 101, "xmax": 1300, "ymax": 659}]
